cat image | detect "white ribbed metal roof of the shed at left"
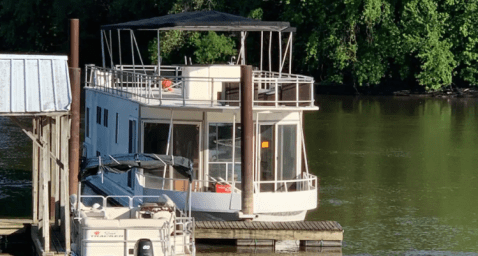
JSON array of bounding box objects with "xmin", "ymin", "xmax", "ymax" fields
[{"xmin": 0, "ymin": 54, "xmax": 71, "ymax": 115}]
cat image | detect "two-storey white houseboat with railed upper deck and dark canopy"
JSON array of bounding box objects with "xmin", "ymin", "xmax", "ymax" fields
[{"xmin": 83, "ymin": 11, "xmax": 318, "ymax": 221}]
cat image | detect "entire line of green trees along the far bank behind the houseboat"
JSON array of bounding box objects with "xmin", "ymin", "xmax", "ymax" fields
[{"xmin": 0, "ymin": 0, "xmax": 478, "ymax": 91}]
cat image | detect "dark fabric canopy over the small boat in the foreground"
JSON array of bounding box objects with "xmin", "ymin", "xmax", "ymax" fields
[{"xmin": 78, "ymin": 154, "xmax": 193, "ymax": 181}]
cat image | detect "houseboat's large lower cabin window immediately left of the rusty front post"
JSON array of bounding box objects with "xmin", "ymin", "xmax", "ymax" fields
[{"xmin": 208, "ymin": 123, "xmax": 241, "ymax": 187}]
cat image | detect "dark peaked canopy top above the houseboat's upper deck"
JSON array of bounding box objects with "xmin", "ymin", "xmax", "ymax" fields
[{"xmin": 101, "ymin": 11, "xmax": 293, "ymax": 31}]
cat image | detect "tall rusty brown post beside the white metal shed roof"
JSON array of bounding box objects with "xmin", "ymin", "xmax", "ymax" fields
[{"xmin": 68, "ymin": 19, "xmax": 81, "ymax": 195}]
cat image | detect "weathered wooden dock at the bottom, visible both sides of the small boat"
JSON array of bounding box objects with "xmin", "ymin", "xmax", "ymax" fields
[{"xmin": 0, "ymin": 219, "xmax": 344, "ymax": 249}]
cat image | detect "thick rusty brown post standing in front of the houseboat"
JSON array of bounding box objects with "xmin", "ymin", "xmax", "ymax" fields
[{"xmin": 241, "ymin": 65, "xmax": 254, "ymax": 221}]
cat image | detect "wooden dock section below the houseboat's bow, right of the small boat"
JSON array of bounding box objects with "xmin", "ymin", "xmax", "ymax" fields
[{"xmin": 194, "ymin": 221, "xmax": 344, "ymax": 246}]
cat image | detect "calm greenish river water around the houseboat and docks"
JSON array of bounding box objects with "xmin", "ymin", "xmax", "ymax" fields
[{"xmin": 0, "ymin": 96, "xmax": 478, "ymax": 255}]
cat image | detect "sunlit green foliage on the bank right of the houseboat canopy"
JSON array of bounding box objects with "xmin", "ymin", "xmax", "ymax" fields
[{"xmin": 283, "ymin": 0, "xmax": 478, "ymax": 90}]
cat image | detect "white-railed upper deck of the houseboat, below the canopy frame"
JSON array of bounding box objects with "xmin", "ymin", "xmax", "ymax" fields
[{"xmin": 85, "ymin": 65, "xmax": 318, "ymax": 111}]
